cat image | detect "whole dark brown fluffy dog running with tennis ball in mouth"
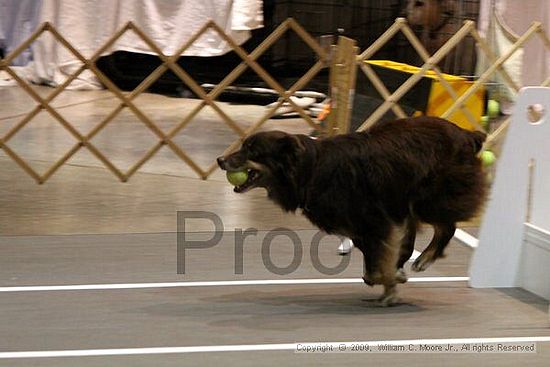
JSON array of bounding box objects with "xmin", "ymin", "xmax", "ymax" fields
[{"xmin": 218, "ymin": 117, "xmax": 485, "ymax": 305}]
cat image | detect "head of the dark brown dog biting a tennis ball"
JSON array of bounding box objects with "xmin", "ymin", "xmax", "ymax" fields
[{"xmin": 218, "ymin": 131, "xmax": 308, "ymax": 207}]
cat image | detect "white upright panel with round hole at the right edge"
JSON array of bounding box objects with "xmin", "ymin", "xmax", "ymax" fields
[{"xmin": 470, "ymin": 87, "xmax": 550, "ymax": 300}]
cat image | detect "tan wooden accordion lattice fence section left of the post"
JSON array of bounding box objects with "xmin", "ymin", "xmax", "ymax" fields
[{"xmin": 0, "ymin": 19, "xmax": 328, "ymax": 183}]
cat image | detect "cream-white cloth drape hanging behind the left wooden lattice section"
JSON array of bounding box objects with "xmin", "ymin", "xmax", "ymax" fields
[{"xmin": 2, "ymin": 0, "xmax": 263, "ymax": 89}]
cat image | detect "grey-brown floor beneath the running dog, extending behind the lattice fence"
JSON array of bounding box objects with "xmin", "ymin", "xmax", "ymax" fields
[{"xmin": 0, "ymin": 87, "xmax": 550, "ymax": 366}]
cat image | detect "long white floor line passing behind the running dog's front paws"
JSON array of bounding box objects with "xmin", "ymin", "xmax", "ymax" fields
[{"xmin": 0, "ymin": 277, "xmax": 469, "ymax": 292}]
